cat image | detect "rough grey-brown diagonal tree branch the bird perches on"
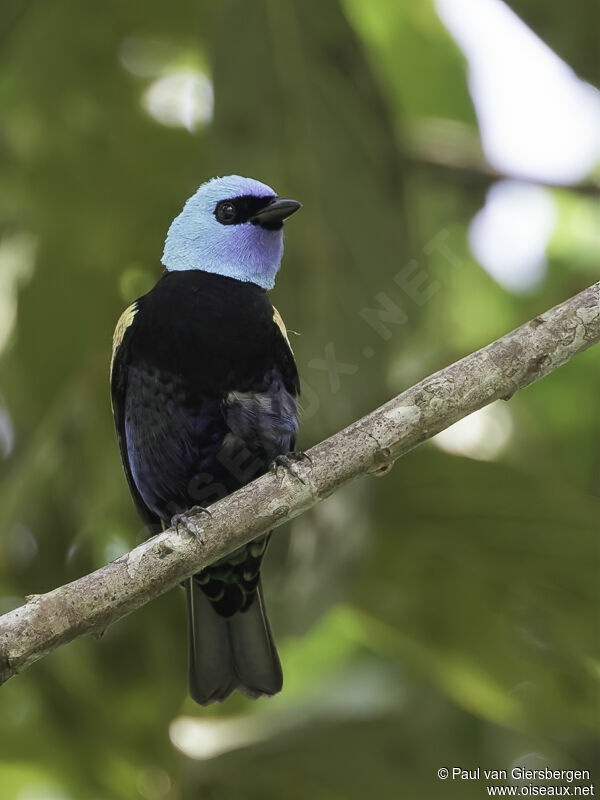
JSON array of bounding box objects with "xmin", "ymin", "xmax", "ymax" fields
[{"xmin": 0, "ymin": 283, "xmax": 600, "ymax": 683}]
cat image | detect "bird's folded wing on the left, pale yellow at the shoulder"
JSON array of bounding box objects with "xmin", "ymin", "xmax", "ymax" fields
[{"xmin": 110, "ymin": 301, "xmax": 162, "ymax": 531}]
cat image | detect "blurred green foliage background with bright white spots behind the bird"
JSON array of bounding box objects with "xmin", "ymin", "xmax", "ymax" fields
[{"xmin": 0, "ymin": 0, "xmax": 600, "ymax": 800}]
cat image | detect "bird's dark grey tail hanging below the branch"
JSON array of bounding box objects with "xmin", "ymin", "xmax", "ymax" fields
[{"xmin": 186, "ymin": 578, "xmax": 283, "ymax": 706}]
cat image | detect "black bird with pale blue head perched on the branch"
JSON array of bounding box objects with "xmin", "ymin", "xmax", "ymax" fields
[{"xmin": 111, "ymin": 175, "xmax": 300, "ymax": 705}]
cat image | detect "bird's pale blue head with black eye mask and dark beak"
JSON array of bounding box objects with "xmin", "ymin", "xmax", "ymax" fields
[{"xmin": 162, "ymin": 175, "xmax": 300, "ymax": 289}]
